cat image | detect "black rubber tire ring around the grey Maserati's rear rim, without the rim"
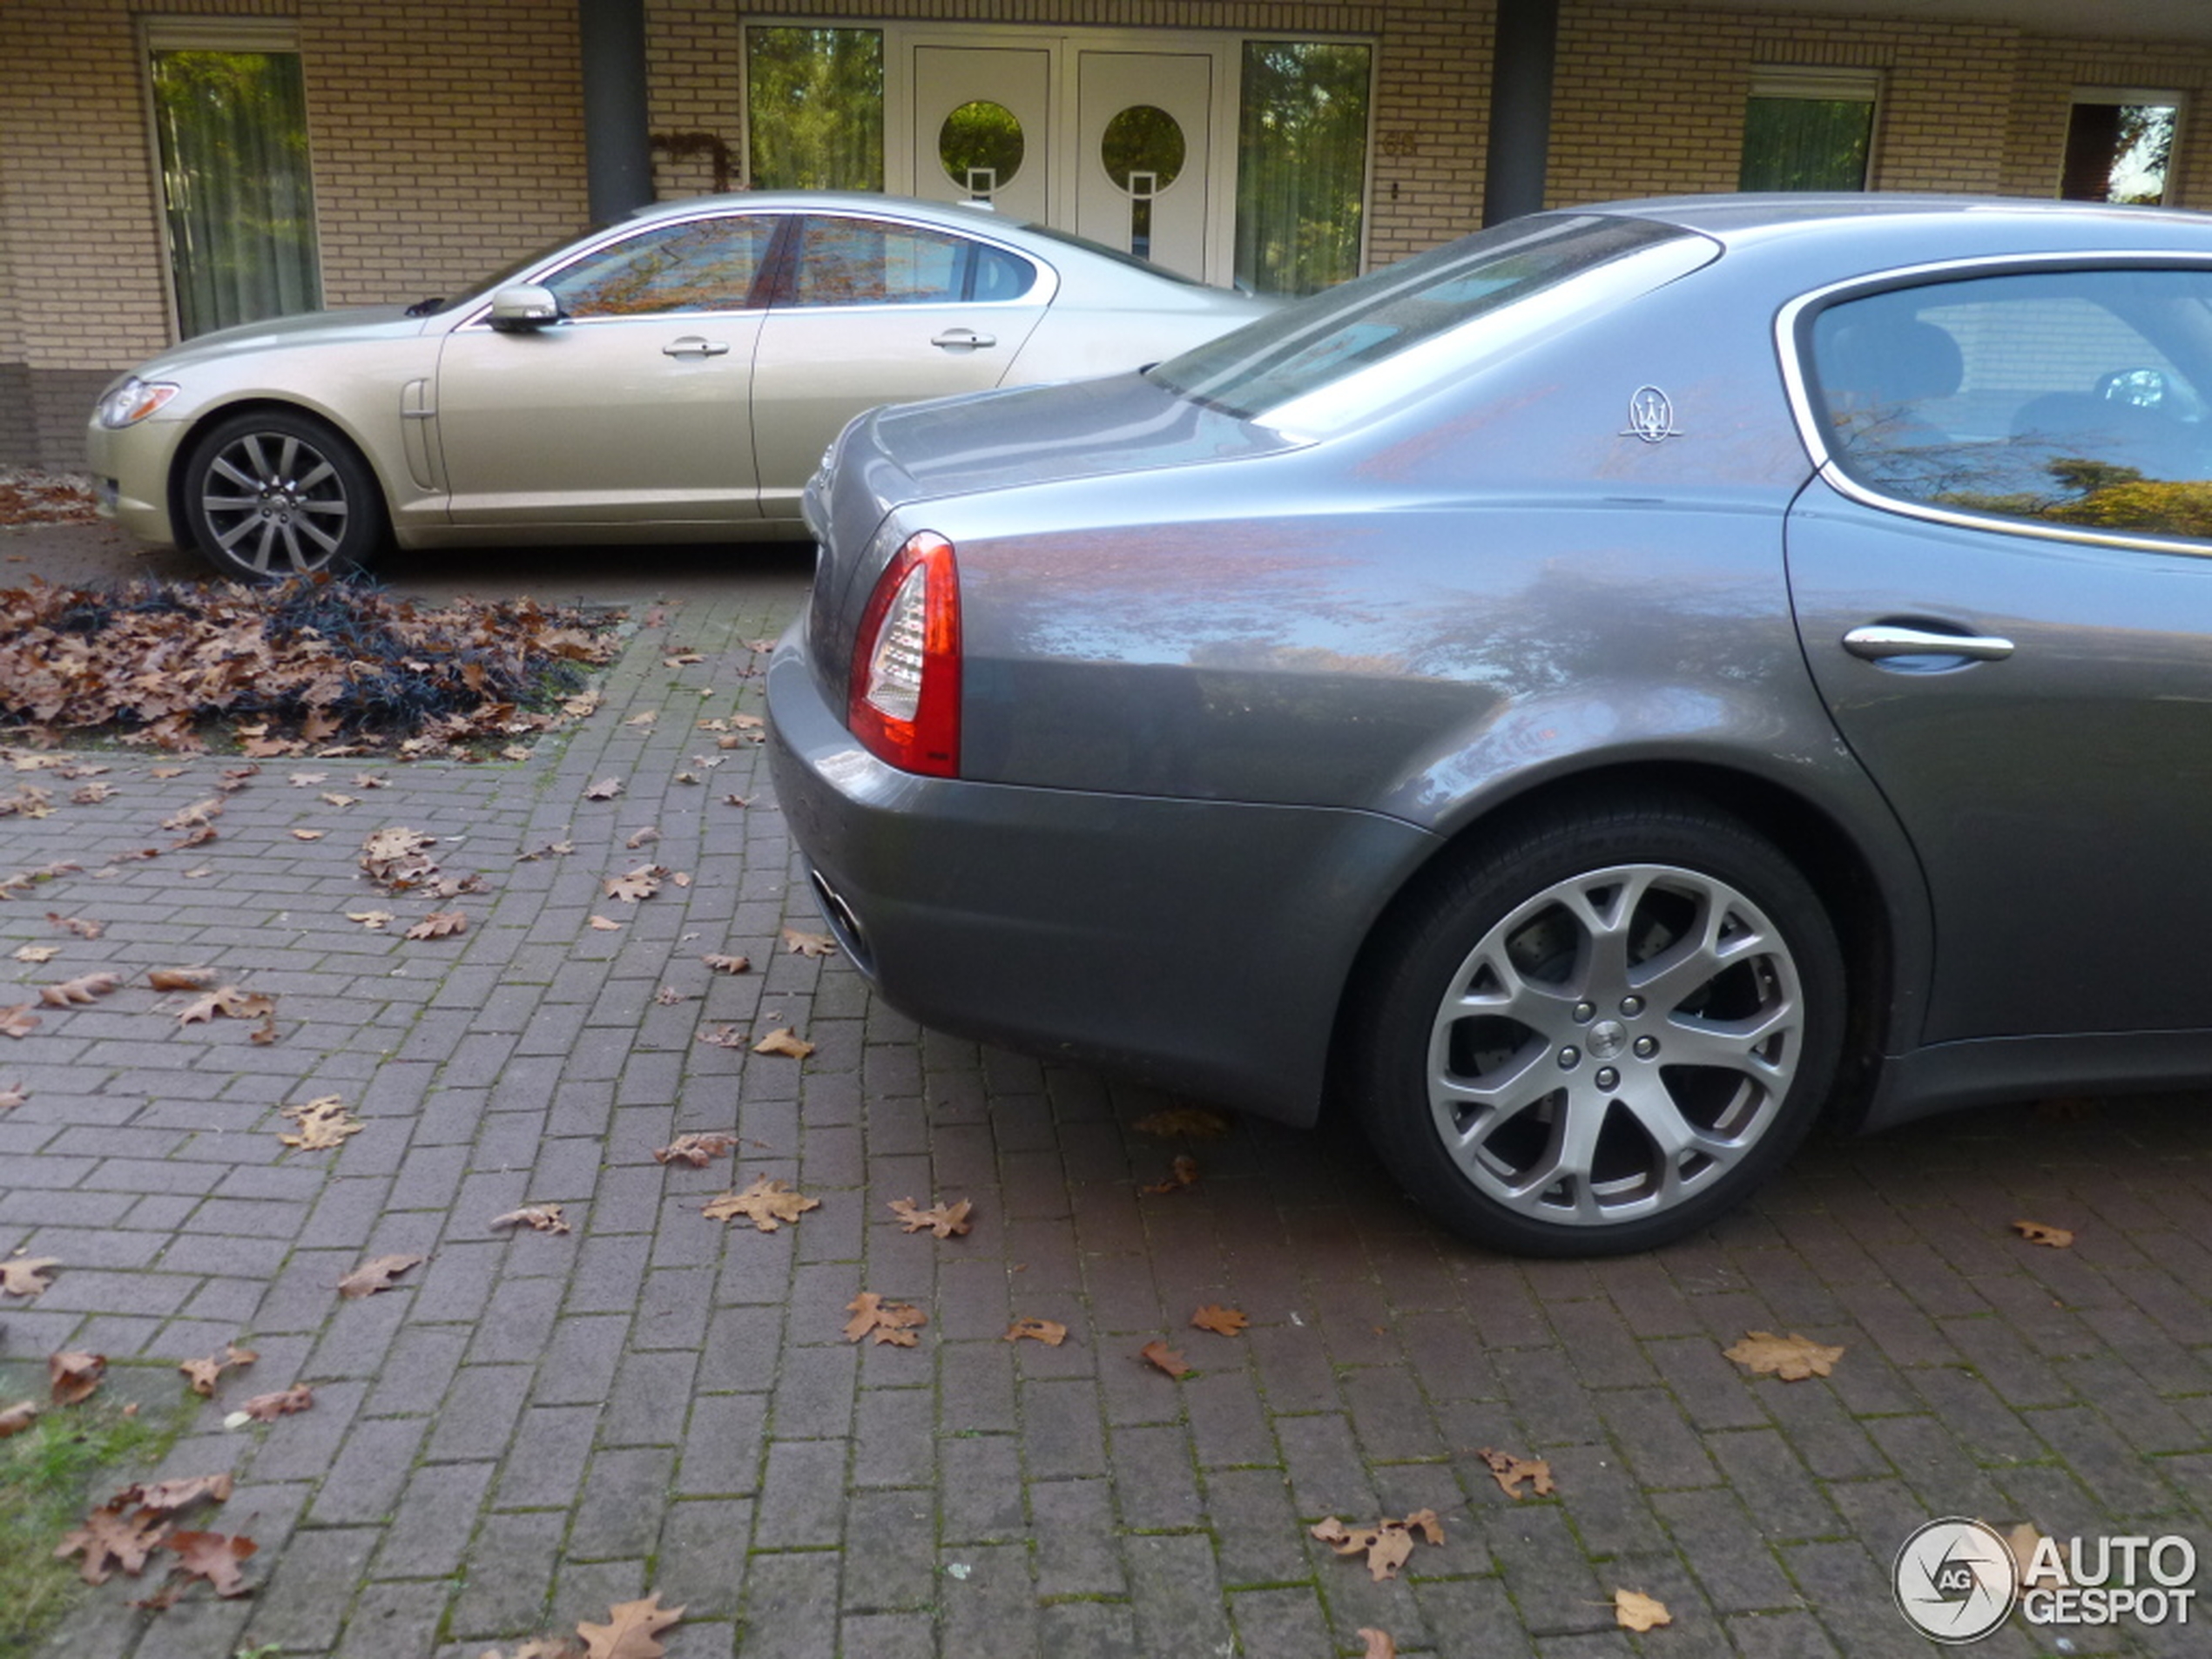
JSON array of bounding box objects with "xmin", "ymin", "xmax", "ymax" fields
[{"xmin": 1352, "ymin": 806, "xmax": 1847, "ymax": 1257}]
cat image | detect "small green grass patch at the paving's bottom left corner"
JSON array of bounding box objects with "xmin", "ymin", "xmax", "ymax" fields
[{"xmin": 0, "ymin": 1372, "xmax": 197, "ymax": 1659}]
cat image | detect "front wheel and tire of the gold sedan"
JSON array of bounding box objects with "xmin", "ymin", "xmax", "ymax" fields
[{"xmin": 181, "ymin": 409, "xmax": 385, "ymax": 582}]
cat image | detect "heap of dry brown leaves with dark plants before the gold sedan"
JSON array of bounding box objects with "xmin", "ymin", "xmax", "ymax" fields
[{"xmin": 0, "ymin": 579, "xmax": 615, "ymax": 750}]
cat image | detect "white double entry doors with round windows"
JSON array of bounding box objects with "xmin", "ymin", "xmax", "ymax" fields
[{"xmin": 894, "ymin": 40, "xmax": 1214, "ymax": 277}]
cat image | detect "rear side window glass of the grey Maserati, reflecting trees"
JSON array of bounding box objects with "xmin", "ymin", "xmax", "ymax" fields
[{"xmin": 1811, "ymin": 270, "xmax": 2212, "ymax": 540}]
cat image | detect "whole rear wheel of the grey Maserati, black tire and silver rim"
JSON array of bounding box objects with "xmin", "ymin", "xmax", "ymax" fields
[{"xmin": 1347, "ymin": 796, "xmax": 1847, "ymax": 1257}]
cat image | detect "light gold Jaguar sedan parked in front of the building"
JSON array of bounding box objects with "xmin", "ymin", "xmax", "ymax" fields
[{"xmin": 89, "ymin": 192, "xmax": 1272, "ymax": 579}]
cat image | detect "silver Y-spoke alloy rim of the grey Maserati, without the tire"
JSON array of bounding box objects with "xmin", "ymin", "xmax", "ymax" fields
[{"xmin": 1429, "ymin": 865, "xmax": 1805, "ymax": 1225}]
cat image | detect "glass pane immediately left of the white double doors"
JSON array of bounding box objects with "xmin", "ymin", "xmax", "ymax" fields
[{"xmin": 745, "ymin": 26, "xmax": 882, "ymax": 190}]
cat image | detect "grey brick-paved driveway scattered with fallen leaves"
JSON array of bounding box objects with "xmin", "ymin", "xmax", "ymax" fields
[{"xmin": 0, "ymin": 535, "xmax": 2212, "ymax": 1659}]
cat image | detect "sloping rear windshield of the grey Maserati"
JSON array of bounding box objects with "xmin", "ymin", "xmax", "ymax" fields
[{"xmin": 1146, "ymin": 214, "xmax": 1703, "ymax": 421}]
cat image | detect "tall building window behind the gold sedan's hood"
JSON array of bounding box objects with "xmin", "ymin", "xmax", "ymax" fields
[{"xmin": 146, "ymin": 20, "xmax": 323, "ymax": 339}]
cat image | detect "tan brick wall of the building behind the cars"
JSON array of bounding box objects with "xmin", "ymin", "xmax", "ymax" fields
[{"xmin": 12, "ymin": 0, "xmax": 2212, "ymax": 464}]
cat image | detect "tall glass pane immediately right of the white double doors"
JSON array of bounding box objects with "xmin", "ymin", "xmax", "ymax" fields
[{"xmin": 1237, "ymin": 40, "xmax": 1372, "ymax": 294}]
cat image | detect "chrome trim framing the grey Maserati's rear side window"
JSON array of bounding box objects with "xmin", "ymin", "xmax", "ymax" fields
[{"xmin": 1774, "ymin": 247, "xmax": 2212, "ymax": 557}]
